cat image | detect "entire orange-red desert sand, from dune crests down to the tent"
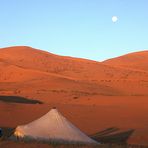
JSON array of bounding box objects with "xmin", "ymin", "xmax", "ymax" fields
[{"xmin": 0, "ymin": 46, "xmax": 148, "ymax": 143}]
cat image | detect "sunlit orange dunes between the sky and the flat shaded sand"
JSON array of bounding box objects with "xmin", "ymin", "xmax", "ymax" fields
[{"xmin": 0, "ymin": 46, "xmax": 148, "ymax": 98}]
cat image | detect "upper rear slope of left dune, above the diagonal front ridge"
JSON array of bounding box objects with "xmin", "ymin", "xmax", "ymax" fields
[{"xmin": 0, "ymin": 47, "xmax": 148, "ymax": 80}]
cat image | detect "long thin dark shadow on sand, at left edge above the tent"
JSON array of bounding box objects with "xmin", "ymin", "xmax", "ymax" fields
[{"xmin": 0, "ymin": 96, "xmax": 43, "ymax": 104}]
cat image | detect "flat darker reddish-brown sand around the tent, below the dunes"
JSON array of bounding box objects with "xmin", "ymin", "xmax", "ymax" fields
[{"xmin": 0, "ymin": 96, "xmax": 148, "ymax": 144}]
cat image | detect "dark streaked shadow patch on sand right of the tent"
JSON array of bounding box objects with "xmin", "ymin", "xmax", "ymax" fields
[{"xmin": 90, "ymin": 127, "xmax": 134, "ymax": 144}]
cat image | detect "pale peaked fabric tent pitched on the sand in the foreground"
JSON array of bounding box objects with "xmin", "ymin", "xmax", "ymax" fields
[{"xmin": 14, "ymin": 108, "xmax": 97, "ymax": 144}]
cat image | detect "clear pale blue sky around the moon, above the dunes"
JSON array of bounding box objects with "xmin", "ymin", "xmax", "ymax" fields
[{"xmin": 0, "ymin": 0, "xmax": 148, "ymax": 61}]
